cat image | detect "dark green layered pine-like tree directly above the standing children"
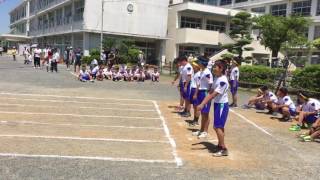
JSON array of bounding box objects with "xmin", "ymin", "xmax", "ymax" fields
[{"xmin": 222, "ymin": 12, "xmax": 253, "ymax": 64}]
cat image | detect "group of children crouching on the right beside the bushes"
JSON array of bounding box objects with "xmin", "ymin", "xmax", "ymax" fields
[{"xmin": 243, "ymin": 86, "xmax": 320, "ymax": 141}]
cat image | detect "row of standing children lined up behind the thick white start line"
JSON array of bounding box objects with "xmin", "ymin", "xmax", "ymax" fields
[{"xmin": 173, "ymin": 56, "xmax": 229, "ymax": 157}]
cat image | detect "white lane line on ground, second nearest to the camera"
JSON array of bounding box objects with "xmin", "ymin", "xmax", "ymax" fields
[{"xmin": 0, "ymin": 134, "xmax": 170, "ymax": 144}]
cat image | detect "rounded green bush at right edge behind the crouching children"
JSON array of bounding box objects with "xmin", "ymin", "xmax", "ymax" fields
[{"xmin": 291, "ymin": 65, "xmax": 320, "ymax": 92}]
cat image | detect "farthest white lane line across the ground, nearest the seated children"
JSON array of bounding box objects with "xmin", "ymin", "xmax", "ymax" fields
[{"xmin": 0, "ymin": 92, "xmax": 152, "ymax": 103}]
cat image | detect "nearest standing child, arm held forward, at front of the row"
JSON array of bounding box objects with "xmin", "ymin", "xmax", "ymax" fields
[{"xmin": 198, "ymin": 60, "xmax": 229, "ymax": 157}]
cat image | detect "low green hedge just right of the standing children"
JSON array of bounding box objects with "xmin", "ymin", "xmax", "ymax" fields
[{"xmin": 240, "ymin": 66, "xmax": 284, "ymax": 86}]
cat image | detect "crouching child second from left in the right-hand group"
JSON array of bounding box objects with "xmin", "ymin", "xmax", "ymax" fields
[{"xmin": 272, "ymin": 87, "xmax": 296, "ymax": 121}]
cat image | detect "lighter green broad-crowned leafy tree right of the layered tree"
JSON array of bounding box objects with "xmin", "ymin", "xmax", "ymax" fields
[{"xmin": 254, "ymin": 15, "xmax": 310, "ymax": 64}]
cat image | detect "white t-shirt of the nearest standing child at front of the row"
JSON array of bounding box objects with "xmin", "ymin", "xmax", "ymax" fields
[{"xmin": 213, "ymin": 75, "xmax": 229, "ymax": 103}]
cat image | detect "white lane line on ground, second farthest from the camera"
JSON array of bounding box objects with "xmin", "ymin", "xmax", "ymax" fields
[{"xmin": 0, "ymin": 103, "xmax": 156, "ymax": 112}]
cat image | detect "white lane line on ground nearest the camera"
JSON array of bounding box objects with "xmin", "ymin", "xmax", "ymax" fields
[{"xmin": 0, "ymin": 153, "xmax": 175, "ymax": 164}]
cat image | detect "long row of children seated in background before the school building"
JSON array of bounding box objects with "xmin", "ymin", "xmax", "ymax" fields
[{"xmin": 79, "ymin": 64, "xmax": 160, "ymax": 82}]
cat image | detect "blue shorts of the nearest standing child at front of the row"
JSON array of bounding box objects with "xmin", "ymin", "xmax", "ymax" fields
[{"xmin": 213, "ymin": 103, "xmax": 229, "ymax": 128}]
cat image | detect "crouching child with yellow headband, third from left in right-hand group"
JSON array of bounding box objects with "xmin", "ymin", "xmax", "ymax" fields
[{"xmin": 289, "ymin": 92, "xmax": 320, "ymax": 131}]
